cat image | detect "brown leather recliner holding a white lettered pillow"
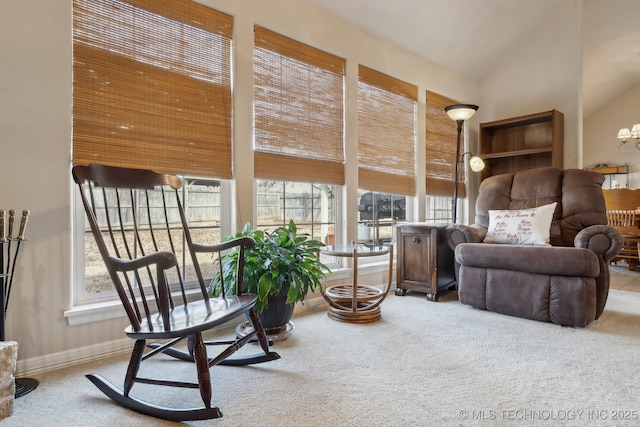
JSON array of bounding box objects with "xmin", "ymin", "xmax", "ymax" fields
[{"xmin": 446, "ymin": 168, "xmax": 623, "ymax": 326}]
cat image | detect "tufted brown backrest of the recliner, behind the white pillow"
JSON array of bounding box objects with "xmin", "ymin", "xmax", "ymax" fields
[{"xmin": 475, "ymin": 168, "xmax": 607, "ymax": 246}]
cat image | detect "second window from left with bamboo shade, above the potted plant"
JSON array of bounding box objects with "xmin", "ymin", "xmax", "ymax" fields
[{"xmin": 254, "ymin": 26, "xmax": 345, "ymax": 247}]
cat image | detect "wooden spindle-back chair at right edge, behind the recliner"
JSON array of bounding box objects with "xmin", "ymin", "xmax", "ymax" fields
[{"xmin": 602, "ymin": 188, "xmax": 640, "ymax": 271}]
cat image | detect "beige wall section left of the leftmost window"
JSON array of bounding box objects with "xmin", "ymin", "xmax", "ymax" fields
[{"xmin": 0, "ymin": 0, "xmax": 133, "ymax": 369}]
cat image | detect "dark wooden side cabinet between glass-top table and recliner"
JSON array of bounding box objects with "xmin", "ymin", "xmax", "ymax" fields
[{"xmin": 395, "ymin": 223, "xmax": 456, "ymax": 301}]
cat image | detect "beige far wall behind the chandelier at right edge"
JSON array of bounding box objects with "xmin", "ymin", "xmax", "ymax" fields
[{"xmin": 584, "ymin": 85, "xmax": 640, "ymax": 188}]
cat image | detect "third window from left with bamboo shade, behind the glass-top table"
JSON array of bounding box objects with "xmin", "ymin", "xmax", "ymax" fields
[{"xmin": 358, "ymin": 65, "xmax": 418, "ymax": 245}]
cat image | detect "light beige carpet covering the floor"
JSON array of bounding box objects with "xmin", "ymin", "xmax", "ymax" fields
[{"xmin": 1, "ymin": 291, "xmax": 640, "ymax": 427}]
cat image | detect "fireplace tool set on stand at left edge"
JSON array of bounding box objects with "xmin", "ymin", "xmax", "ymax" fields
[{"xmin": 0, "ymin": 209, "xmax": 38, "ymax": 397}]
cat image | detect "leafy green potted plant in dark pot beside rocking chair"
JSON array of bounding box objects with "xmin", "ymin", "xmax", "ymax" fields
[{"xmin": 213, "ymin": 220, "xmax": 330, "ymax": 334}]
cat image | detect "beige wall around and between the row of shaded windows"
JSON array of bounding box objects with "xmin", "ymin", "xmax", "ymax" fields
[{"xmin": 0, "ymin": 0, "xmax": 479, "ymax": 374}]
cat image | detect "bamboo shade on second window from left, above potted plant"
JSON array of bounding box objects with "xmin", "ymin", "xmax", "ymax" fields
[{"xmin": 254, "ymin": 26, "xmax": 345, "ymax": 185}]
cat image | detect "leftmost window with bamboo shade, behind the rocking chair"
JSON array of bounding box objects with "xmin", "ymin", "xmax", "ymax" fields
[{"xmin": 72, "ymin": 0, "xmax": 233, "ymax": 304}]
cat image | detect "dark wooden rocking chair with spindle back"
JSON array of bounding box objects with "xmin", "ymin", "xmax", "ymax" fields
[{"xmin": 72, "ymin": 165, "xmax": 280, "ymax": 421}]
